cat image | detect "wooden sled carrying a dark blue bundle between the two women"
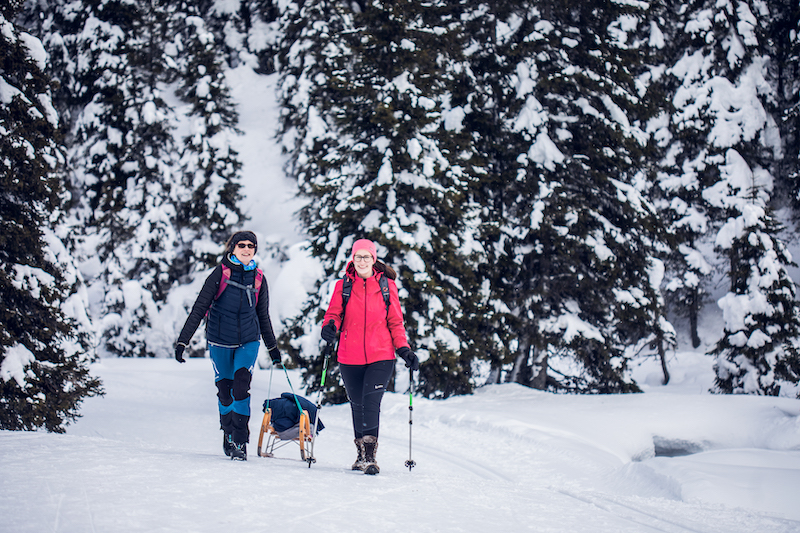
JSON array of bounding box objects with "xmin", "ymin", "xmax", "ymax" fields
[{"xmin": 258, "ymin": 392, "xmax": 325, "ymax": 461}]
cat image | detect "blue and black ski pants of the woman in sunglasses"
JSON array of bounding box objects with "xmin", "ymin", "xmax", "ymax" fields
[{"xmin": 209, "ymin": 341, "xmax": 258, "ymax": 443}]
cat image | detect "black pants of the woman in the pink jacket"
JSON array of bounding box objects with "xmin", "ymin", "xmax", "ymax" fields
[{"xmin": 339, "ymin": 360, "xmax": 394, "ymax": 439}]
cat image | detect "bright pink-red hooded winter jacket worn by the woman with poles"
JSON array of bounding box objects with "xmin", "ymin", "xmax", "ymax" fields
[{"xmin": 323, "ymin": 263, "xmax": 408, "ymax": 365}]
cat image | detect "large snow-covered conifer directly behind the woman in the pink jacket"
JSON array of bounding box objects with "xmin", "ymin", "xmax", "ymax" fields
[{"xmin": 282, "ymin": 1, "xmax": 484, "ymax": 398}]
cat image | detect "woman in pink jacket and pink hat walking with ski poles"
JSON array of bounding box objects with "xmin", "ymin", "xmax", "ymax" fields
[{"xmin": 322, "ymin": 239, "xmax": 419, "ymax": 475}]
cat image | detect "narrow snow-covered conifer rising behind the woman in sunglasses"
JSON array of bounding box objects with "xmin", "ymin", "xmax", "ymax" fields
[{"xmin": 167, "ymin": 10, "xmax": 243, "ymax": 353}]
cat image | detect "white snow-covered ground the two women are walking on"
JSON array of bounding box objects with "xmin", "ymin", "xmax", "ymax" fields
[{"xmin": 0, "ymin": 353, "xmax": 800, "ymax": 533}]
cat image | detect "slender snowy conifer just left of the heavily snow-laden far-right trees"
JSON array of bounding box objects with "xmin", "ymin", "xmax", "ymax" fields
[{"xmin": 645, "ymin": 6, "xmax": 721, "ymax": 348}]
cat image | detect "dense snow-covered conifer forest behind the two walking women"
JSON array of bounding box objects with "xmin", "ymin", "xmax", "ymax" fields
[{"xmin": 0, "ymin": 0, "xmax": 800, "ymax": 431}]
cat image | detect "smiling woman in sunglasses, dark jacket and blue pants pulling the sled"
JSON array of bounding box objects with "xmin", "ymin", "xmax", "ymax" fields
[{"xmin": 175, "ymin": 231, "xmax": 281, "ymax": 461}]
